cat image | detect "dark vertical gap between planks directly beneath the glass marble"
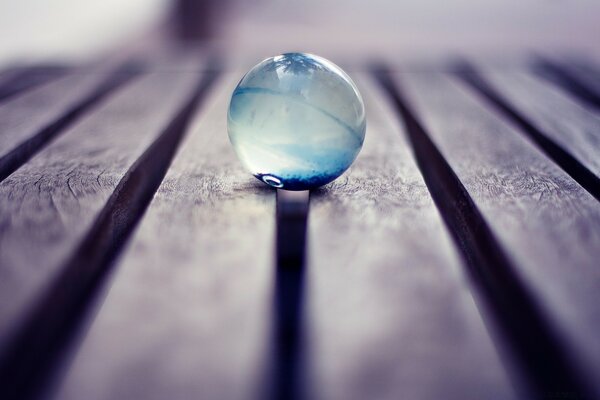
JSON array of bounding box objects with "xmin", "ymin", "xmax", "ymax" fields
[{"xmin": 271, "ymin": 190, "xmax": 309, "ymax": 400}]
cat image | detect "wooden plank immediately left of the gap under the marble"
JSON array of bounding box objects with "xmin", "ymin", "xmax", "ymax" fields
[{"xmin": 56, "ymin": 74, "xmax": 275, "ymax": 400}]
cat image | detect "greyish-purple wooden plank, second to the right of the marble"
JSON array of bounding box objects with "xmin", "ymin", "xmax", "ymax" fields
[{"xmin": 401, "ymin": 74, "xmax": 600, "ymax": 396}]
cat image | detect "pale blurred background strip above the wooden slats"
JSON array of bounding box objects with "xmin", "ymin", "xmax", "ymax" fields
[{"xmin": 0, "ymin": 0, "xmax": 600, "ymax": 66}]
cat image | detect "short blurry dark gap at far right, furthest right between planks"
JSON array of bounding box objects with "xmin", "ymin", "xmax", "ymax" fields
[{"xmin": 533, "ymin": 57, "xmax": 600, "ymax": 110}]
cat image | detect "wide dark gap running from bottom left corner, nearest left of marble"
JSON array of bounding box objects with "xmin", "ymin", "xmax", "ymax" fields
[{"xmin": 0, "ymin": 66, "xmax": 217, "ymax": 400}]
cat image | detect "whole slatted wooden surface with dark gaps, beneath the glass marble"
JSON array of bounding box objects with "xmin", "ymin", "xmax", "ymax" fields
[{"xmin": 0, "ymin": 53, "xmax": 600, "ymax": 400}]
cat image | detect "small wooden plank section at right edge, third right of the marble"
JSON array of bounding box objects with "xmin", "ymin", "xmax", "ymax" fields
[{"xmin": 485, "ymin": 72, "xmax": 600, "ymax": 177}]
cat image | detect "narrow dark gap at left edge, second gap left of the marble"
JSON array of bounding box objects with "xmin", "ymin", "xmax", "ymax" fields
[{"xmin": 0, "ymin": 65, "xmax": 140, "ymax": 182}]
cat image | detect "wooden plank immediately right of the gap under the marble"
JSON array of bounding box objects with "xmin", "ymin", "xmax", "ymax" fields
[{"xmin": 304, "ymin": 76, "xmax": 513, "ymax": 399}]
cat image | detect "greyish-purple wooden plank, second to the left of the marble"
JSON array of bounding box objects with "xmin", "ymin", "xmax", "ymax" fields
[{"xmin": 0, "ymin": 74, "xmax": 202, "ymax": 350}]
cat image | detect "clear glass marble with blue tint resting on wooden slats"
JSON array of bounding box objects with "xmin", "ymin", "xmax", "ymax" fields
[{"xmin": 227, "ymin": 53, "xmax": 366, "ymax": 190}]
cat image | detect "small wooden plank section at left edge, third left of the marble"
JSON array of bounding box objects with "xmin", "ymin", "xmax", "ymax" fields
[{"xmin": 0, "ymin": 72, "xmax": 118, "ymax": 158}]
